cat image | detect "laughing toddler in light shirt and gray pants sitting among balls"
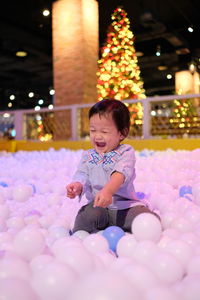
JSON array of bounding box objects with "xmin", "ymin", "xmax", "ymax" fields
[{"xmin": 67, "ymin": 99, "xmax": 157, "ymax": 233}]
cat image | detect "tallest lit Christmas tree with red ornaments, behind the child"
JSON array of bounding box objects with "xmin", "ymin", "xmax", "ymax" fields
[{"xmin": 97, "ymin": 8, "xmax": 145, "ymax": 124}]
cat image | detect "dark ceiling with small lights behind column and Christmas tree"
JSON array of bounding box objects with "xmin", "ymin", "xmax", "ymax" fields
[{"xmin": 0, "ymin": 0, "xmax": 200, "ymax": 110}]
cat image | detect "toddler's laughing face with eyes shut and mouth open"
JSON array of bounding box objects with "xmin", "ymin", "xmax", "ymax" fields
[{"xmin": 90, "ymin": 114, "xmax": 124, "ymax": 154}]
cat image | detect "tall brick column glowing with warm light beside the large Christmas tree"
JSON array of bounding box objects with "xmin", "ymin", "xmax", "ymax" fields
[{"xmin": 52, "ymin": 0, "xmax": 98, "ymax": 106}]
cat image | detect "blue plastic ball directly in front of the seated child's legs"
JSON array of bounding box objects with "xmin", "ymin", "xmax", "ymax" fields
[{"xmin": 102, "ymin": 226, "xmax": 125, "ymax": 252}]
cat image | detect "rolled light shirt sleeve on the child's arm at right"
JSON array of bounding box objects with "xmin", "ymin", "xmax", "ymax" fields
[{"xmin": 112, "ymin": 145, "xmax": 136, "ymax": 182}]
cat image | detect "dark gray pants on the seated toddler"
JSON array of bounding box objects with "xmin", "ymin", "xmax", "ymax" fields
[{"xmin": 73, "ymin": 202, "xmax": 159, "ymax": 233}]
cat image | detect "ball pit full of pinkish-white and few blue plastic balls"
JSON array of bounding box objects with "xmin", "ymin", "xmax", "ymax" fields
[{"xmin": 0, "ymin": 149, "xmax": 200, "ymax": 300}]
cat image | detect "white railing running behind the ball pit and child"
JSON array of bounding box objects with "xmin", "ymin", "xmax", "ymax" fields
[{"xmin": 0, "ymin": 94, "xmax": 200, "ymax": 140}]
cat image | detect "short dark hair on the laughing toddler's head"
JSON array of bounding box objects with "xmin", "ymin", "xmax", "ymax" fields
[{"xmin": 89, "ymin": 99, "xmax": 130, "ymax": 137}]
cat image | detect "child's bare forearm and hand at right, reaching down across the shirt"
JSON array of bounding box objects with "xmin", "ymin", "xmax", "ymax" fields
[{"xmin": 94, "ymin": 172, "xmax": 125, "ymax": 207}]
